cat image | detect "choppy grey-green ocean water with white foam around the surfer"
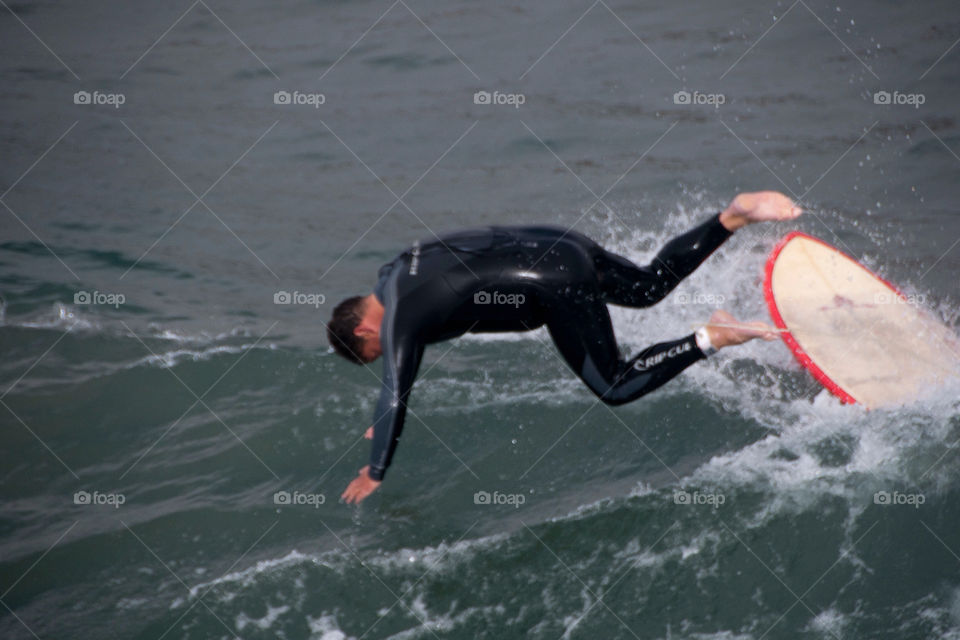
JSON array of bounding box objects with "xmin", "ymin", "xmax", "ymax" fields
[{"xmin": 0, "ymin": 0, "xmax": 960, "ymax": 640}]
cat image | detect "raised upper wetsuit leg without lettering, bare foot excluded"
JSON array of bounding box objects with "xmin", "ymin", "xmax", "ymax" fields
[{"xmin": 593, "ymin": 215, "xmax": 730, "ymax": 307}]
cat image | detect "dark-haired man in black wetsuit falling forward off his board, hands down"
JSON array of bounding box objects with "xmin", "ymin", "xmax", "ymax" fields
[{"xmin": 327, "ymin": 191, "xmax": 801, "ymax": 503}]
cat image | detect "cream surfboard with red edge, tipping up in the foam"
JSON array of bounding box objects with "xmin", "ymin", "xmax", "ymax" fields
[{"xmin": 763, "ymin": 231, "xmax": 960, "ymax": 408}]
